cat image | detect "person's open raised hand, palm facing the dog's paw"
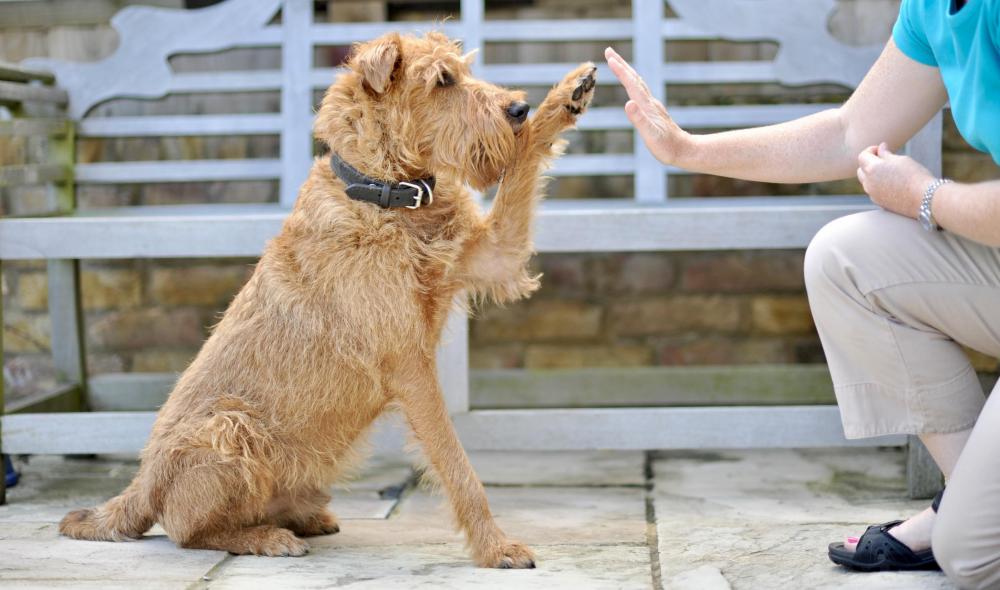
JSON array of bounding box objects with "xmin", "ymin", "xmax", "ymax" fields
[{"xmin": 604, "ymin": 47, "xmax": 691, "ymax": 165}]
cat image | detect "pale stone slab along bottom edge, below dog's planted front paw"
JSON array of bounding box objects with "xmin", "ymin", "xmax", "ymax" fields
[{"xmin": 206, "ymin": 544, "xmax": 652, "ymax": 590}]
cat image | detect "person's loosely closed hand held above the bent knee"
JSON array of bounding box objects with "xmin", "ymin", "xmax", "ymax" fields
[{"xmin": 858, "ymin": 142, "xmax": 934, "ymax": 219}]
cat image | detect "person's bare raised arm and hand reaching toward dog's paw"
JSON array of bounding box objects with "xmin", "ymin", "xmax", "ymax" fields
[{"xmin": 605, "ymin": 40, "xmax": 947, "ymax": 182}]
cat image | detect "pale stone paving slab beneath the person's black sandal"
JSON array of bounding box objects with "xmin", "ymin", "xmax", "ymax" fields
[{"xmin": 653, "ymin": 449, "xmax": 952, "ymax": 590}]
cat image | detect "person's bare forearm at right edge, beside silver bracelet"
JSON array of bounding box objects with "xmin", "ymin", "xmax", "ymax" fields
[{"xmin": 932, "ymin": 180, "xmax": 1000, "ymax": 247}]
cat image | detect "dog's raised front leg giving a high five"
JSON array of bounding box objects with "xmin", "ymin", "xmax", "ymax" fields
[{"xmin": 464, "ymin": 63, "xmax": 597, "ymax": 302}]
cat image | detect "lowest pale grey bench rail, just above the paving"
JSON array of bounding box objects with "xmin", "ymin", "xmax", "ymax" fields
[{"xmin": 2, "ymin": 406, "xmax": 906, "ymax": 454}]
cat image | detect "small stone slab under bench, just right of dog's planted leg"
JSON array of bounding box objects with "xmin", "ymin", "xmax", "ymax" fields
[{"xmin": 469, "ymin": 451, "xmax": 646, "ymax": 487}]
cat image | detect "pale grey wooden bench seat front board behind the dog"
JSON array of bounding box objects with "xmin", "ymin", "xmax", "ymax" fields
[{"xmin": 0, "ymin": 197, "xmax": 873, "ymax": 260}]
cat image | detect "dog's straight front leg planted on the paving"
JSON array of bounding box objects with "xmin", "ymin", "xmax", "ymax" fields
[{"xmin": 401, "ymin": 360, "xmax": 535, "ymax": 569}]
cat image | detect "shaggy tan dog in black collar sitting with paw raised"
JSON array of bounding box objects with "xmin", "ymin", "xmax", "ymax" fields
[{"xmin": 59, "ymin": 33, "xmax": 595, "ymax": 568}]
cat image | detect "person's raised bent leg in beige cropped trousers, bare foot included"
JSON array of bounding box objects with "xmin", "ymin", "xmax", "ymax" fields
[{"xmin": 805, "ymin": 211, "xmax": 1000, "ymax": 549}]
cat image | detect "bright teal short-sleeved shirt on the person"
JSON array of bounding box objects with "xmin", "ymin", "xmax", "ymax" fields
[{"xmin": 892, "ymin": 0, "xmax": 1000, "ymax": 164}]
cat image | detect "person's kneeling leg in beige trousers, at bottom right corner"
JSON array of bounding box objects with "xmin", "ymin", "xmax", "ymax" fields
[{"xmin": 933, "ymin": 384, "xmax": 1000, "ymax": 588}]
